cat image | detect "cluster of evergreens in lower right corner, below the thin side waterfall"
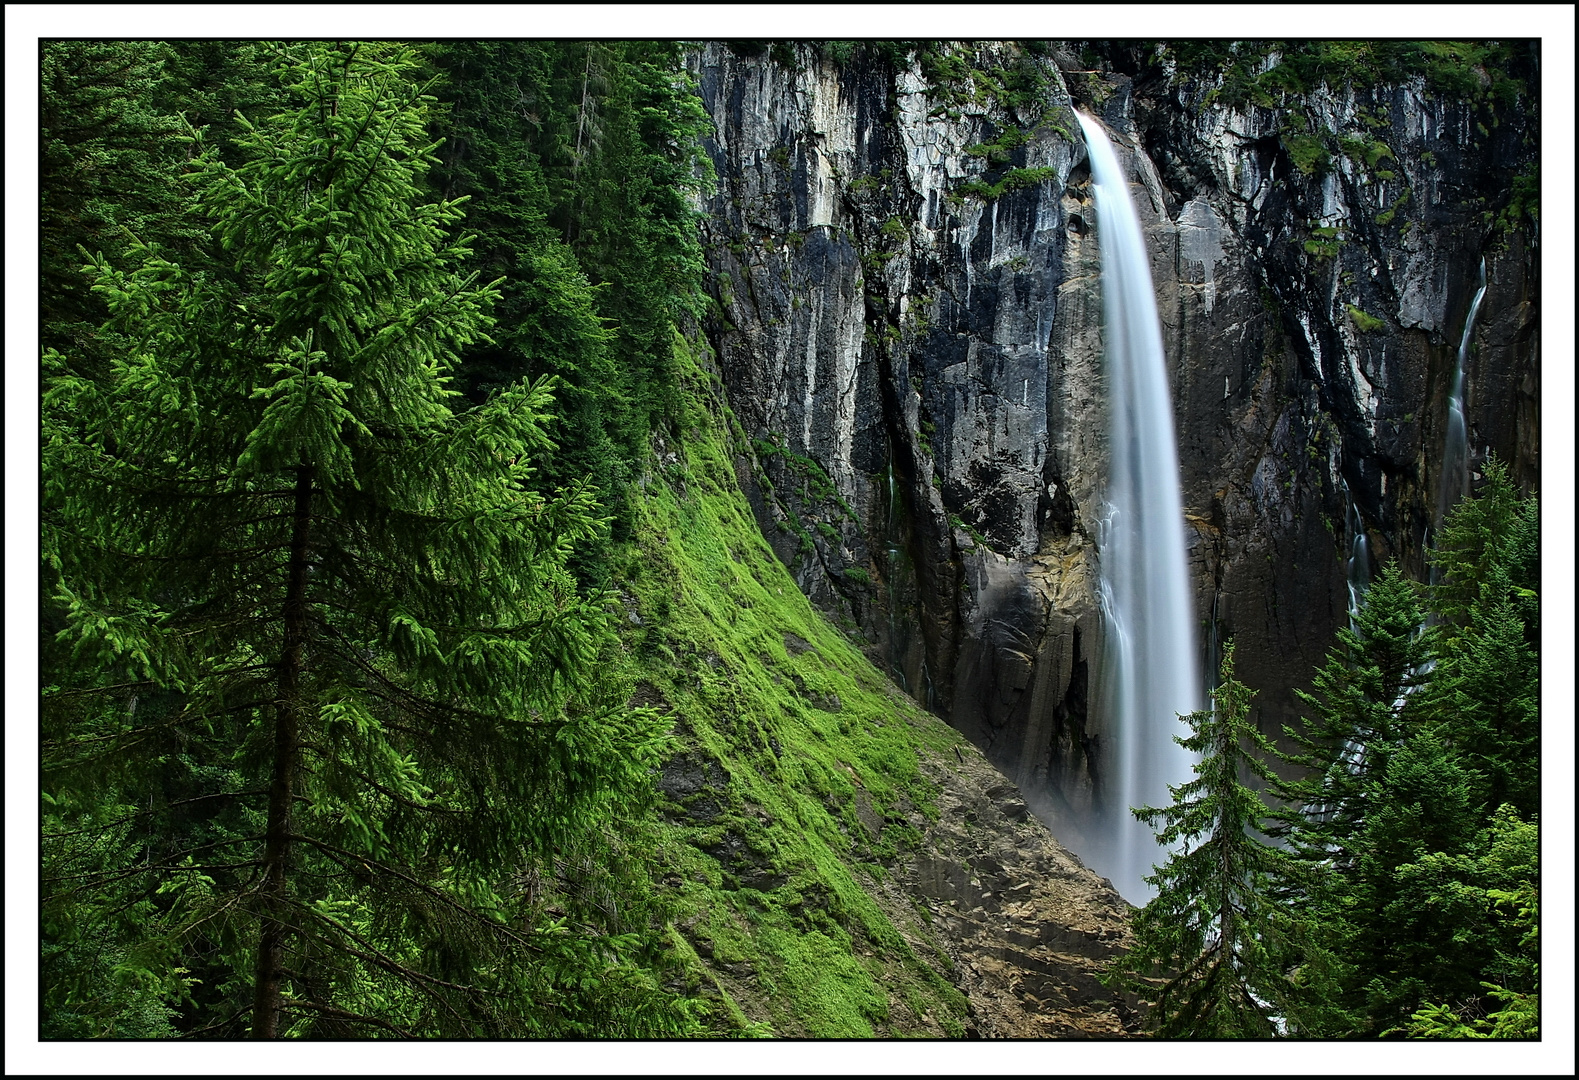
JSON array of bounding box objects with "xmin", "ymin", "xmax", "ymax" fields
[{"xmin": 1268, "ymin": 459, "xmax": 1540, "ymax": 1037}]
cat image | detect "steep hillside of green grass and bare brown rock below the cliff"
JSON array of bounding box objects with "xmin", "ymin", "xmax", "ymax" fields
[{"xmin": 622, "ymin": 333, "xmax": 1131, "ymax": 1037}]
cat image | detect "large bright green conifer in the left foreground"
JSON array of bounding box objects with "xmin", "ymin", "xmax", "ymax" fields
[{"xmin": 43, "ymin": 43, "xmax": 687, "ymax": 1037}]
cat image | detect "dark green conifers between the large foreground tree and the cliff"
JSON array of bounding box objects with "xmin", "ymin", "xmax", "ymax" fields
[{"xmin": 433, "ymin": 41, "xmax": 711, "ymax": 584}]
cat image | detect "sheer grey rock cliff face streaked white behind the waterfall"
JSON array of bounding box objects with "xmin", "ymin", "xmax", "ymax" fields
[{"xmin": 692, "ymin": 43, "xmax": 1538, "ymax": 829}]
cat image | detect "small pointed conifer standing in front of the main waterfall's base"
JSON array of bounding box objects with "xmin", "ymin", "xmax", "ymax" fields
[{"xmin": 1107, "ymin": 644, "xmax": 1292, "ymax": 1039}]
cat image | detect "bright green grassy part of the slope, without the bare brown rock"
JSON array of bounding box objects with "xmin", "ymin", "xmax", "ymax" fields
[{"xmin": 621, "ymin": 331, "xmax": 965, "ymax": 1037}]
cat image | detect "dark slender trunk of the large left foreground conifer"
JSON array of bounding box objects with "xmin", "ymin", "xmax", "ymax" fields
[{"xmin": 253, "ymin": 466, "xmax": 313, "ymax": 1039}]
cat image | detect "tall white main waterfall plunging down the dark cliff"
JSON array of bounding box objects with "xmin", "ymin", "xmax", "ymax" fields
[{"xmin": 1077, "ymin": 114, "xmax": 1200, "ymax": 903}]
